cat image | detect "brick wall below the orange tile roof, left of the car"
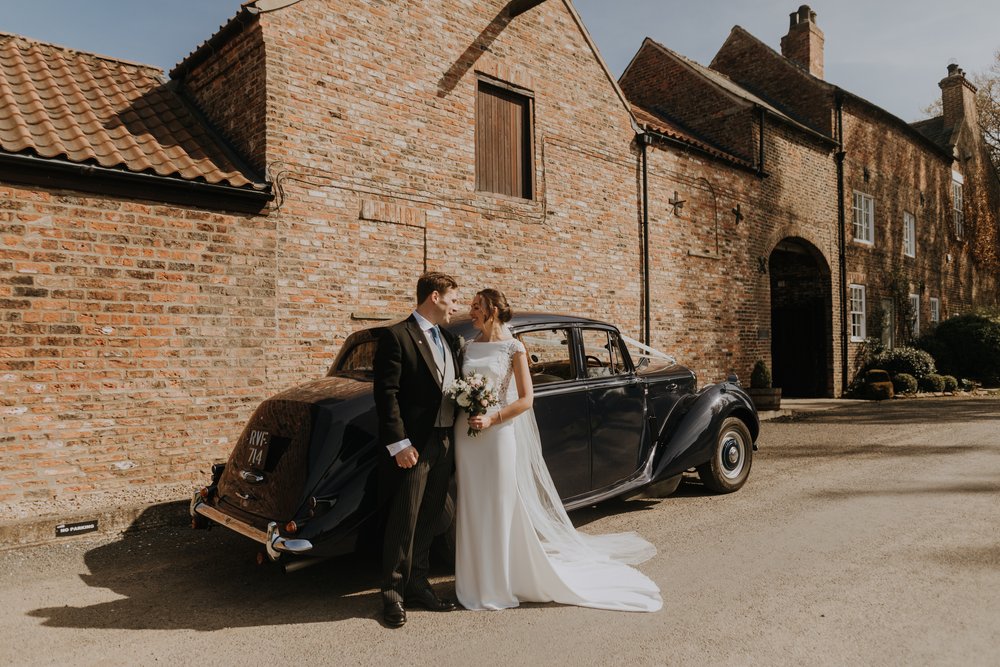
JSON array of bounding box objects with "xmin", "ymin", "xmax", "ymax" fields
[{"xmin": 0, "ymin": 185, "xmax": 275, "ymax": 503}]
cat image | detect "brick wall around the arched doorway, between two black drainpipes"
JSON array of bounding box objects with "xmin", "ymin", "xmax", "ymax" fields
[{"xmin": 649, "ymin": 117, "xmax": 840, "ymax": 395}]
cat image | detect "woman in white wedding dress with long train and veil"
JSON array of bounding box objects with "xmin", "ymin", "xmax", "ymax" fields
[{"xmin": 455, "ymin": 289, "xmax": 663, "ymax": 611}]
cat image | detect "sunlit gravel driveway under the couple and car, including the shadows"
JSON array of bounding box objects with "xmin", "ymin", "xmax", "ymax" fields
[{"xmin": 0, "ymin": 398, "xmax": 1000, "ymax": 665}]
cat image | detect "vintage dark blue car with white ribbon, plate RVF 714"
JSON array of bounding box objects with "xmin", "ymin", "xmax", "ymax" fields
[{"xmin": 191, "ymin": 314, "xmax": 760, "ymax": 564}]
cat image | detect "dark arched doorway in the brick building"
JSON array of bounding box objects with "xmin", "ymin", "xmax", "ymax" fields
[{"xmin": 768, "ymin": 237, "xmax": 833, "ymax": 398}]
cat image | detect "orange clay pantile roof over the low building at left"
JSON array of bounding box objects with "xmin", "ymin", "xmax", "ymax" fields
[{"xmin": 0, "ymin": 33, "xmax": 259, "ymax": 188}]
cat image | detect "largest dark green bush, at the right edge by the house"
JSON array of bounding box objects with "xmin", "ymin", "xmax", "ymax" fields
[{"xmin": 920, "ymin": 311, "xmax": 1000, "ymax": 385}]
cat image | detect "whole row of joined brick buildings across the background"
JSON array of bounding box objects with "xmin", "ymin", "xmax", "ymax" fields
[{"xmin": 0, "ymin": 0, "xmax": 997, "ymax": 512}]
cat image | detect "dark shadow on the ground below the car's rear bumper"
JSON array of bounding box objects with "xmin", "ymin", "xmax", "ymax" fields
[{"xmin": 23, "ymin": 506, "xmax": 390, "ymax": 630}]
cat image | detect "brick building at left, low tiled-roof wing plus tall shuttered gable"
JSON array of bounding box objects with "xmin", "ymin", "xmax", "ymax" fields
[{"xmin": 0, "ymin": 0, "xmax": 642, "ymax": 507}]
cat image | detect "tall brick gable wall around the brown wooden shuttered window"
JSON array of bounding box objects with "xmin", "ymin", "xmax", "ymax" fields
[{"xmin": 249, "ymin": 1, "xmax": 641, "ymax": 378}]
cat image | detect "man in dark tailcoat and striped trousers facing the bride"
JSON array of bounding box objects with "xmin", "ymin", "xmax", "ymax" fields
[{"xmin": 374, "ymin": 273, "xmax": 458, "ymax": 628}]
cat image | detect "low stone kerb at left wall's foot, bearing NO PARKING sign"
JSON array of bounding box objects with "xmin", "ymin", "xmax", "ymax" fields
[{"xmin": 0, "ymin": 500, "xmax": 191, "ymax": 551}]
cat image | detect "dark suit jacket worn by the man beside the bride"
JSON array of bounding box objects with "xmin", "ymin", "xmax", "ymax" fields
[{"xmin": 374, "ymin": 315, "xmax": 459, "ymax": 456}]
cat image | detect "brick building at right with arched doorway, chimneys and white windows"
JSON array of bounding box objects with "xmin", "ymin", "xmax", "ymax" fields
[{"xmin": 620, "ymin": 6, "xmax": 1000, "ymax": 396}]
